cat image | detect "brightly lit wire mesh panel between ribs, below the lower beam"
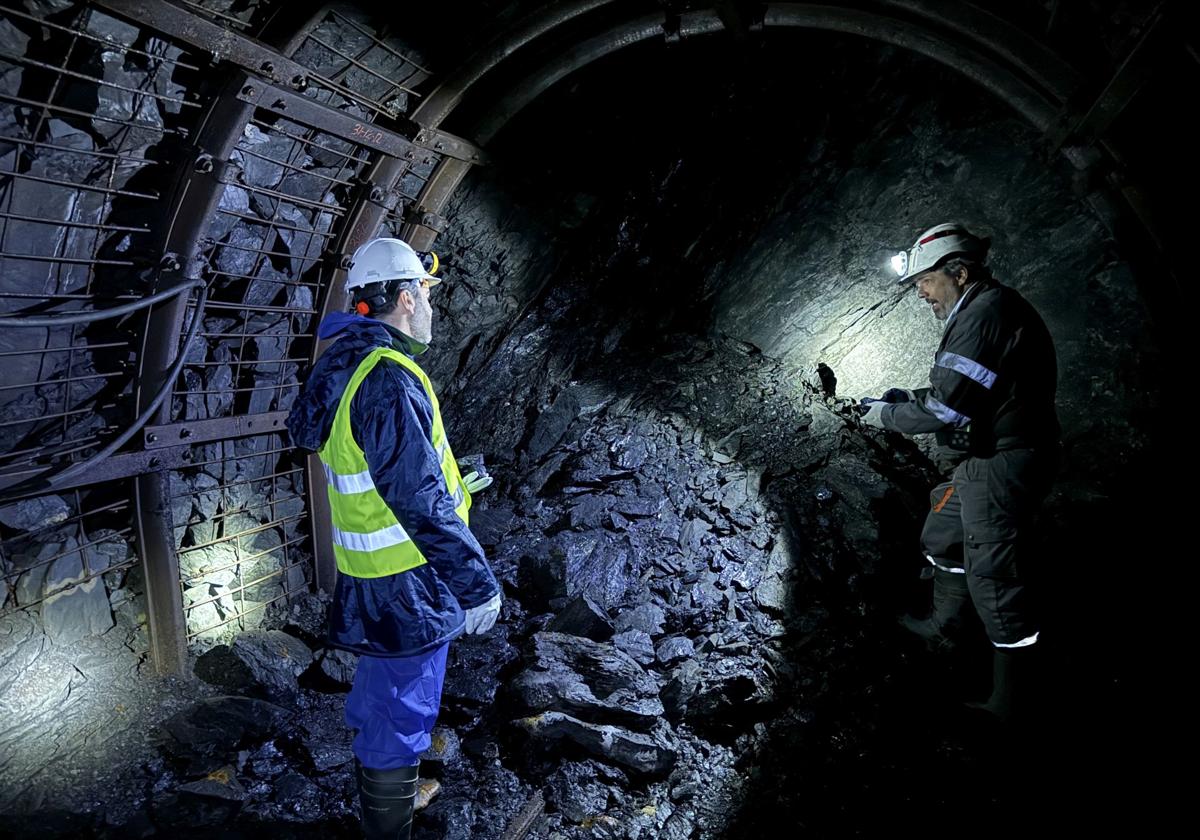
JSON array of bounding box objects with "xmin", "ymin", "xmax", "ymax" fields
[{"xmin": 170, "ymin": 434, "xmax": 312, "ymax": 647}]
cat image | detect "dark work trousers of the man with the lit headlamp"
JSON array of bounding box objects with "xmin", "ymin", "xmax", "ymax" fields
[{"xmin": 920, "ymin": 449, "xmax": 1056, "ymax": 648}]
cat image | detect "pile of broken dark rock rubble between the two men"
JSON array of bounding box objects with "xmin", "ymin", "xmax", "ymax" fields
[{"xmin": 430, "ymin": 337, "xmax": 936, "ymax": 838}]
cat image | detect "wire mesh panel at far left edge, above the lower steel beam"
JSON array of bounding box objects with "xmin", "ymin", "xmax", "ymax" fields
[{"xmin": 0, "ymin": 5, "xmax": 202, "ymax": 480}]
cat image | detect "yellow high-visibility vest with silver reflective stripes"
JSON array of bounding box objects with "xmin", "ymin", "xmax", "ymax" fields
[{"xmin": 317, "ymin": 347, "xmax": 470, "ymax": 577}]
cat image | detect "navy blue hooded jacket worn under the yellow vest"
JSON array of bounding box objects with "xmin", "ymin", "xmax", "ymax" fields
[{"xmin": 288, "ymin": 312, "xmax": 500, "ymax": 656}]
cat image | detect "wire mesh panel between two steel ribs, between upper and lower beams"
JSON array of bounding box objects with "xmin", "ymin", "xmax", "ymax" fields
[{"xmin": 172, "ymin": 110, "xmax": 370, "ymax": 421}]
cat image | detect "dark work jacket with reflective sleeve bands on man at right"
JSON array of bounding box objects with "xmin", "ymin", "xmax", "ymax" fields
[{"xmin": 882, "ymin": 281, "xmax": 1058, "ymax": 456}]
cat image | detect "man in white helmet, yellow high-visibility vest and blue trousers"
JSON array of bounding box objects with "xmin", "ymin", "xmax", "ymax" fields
[{"xmin": 288, "ymin": 239, "xmax": 500, "ymax": 840}]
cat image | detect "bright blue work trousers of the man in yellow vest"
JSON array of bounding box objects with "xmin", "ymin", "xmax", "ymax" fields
[{"xmin": 346, "ymin": 642, "xmax": 450, "ymax": 770}]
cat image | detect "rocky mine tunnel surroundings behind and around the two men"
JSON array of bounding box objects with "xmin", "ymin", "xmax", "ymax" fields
[{"xmin": 0, "ymin": 0, "xmax": 1180, "ymax": 840}]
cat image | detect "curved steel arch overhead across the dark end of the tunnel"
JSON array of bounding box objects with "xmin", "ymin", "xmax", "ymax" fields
[{"xmin": 384, "ymin": 0, "xmax": 1181, "ymax": 360}]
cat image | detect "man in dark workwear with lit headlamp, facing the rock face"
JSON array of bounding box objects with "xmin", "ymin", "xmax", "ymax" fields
[{"xmin": 864, "ymin": 224, "xmax": 1058, "ymax": 719}]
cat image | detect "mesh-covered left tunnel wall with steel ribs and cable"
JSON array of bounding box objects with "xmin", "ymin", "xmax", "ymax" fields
[{"xmin": 0, "ymin": 2, "xmax": 461, "ymax": 671}]
